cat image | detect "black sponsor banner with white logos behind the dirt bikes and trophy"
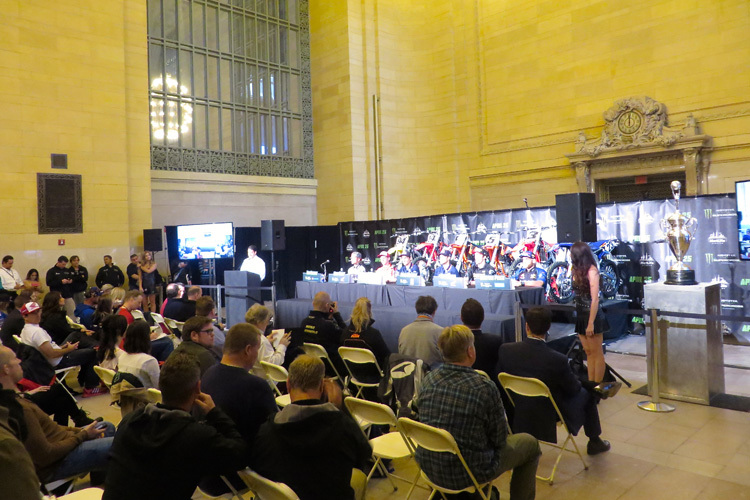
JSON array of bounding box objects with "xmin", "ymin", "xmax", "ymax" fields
[{"xmin": 339, "ymin": 194, "xmax": 750, "ymax": 337}]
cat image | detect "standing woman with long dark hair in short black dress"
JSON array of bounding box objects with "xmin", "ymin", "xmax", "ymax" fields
[{"xmin": 570, "ymin": 241, "xmax": 609, "ymax": 384}]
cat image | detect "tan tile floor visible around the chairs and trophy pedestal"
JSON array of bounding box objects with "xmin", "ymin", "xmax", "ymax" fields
[{"xmin": 75, "ymin": 352, "xmax": 750, "ymax": 500}]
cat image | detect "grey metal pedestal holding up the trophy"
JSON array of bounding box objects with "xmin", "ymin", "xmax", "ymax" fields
[{"xmin": 643, "ymin": 283, "xmax": 724, "ymax": 405}]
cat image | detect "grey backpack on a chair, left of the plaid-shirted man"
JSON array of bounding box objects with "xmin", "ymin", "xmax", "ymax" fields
[{"xmin": 378, "ymin": 353, "xmax": 429, "ymax": 418}]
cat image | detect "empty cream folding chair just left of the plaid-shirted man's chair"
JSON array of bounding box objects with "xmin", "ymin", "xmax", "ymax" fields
[{"xmin": 344, "ymin": 397, "xmax": 419, "ymax": 500}]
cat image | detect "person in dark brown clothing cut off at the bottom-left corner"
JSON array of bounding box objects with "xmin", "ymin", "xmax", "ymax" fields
[{"xmin": 0, "ymin": 389, "xmax": 40, "ymax": 499}]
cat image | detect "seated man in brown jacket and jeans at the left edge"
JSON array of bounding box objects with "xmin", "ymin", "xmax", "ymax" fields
[{"xmin": 0, "ymin": 347, "xmax": 115, "ymax": 484}]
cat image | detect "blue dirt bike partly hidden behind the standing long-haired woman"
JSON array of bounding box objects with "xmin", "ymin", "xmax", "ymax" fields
[{"xmin": 547, "ymin": 239, "xmax": 621, "ymax": 304}]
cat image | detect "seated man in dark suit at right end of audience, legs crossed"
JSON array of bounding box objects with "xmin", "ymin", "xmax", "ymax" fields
[{"xmin": 498, "ymin": 307, "xmax": 610, "ymax": 455}]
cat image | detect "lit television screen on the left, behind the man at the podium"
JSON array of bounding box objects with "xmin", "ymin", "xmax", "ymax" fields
[{"xmin": 177, "ymin": 222, "xmax": 234, "ymax": 260}]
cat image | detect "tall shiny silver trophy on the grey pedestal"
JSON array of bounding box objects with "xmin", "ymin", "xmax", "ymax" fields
[{"xmin": 660, "ymin": 181, "xmax": 698, "ymax": 285}]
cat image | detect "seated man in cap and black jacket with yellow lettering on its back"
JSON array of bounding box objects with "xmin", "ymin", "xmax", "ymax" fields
[{"xmin": 302, "ymin": 292, "xmax": 346, "ymax": 376}]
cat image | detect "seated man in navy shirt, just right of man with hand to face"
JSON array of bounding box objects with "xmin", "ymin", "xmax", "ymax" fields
[{"xmin": 201, "ymin": 323, "xmax": 278, "ymax": 495}]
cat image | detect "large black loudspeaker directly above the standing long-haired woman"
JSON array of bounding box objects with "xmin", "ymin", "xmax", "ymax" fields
[{"xmin": 555, "ymin": 193, "xmax": 597, "ymax": 242}]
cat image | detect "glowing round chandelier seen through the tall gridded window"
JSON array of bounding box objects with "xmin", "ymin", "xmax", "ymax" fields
[{"xmin": 151, "ymin": 73, "xmax": 193, "ymax": 141}]
